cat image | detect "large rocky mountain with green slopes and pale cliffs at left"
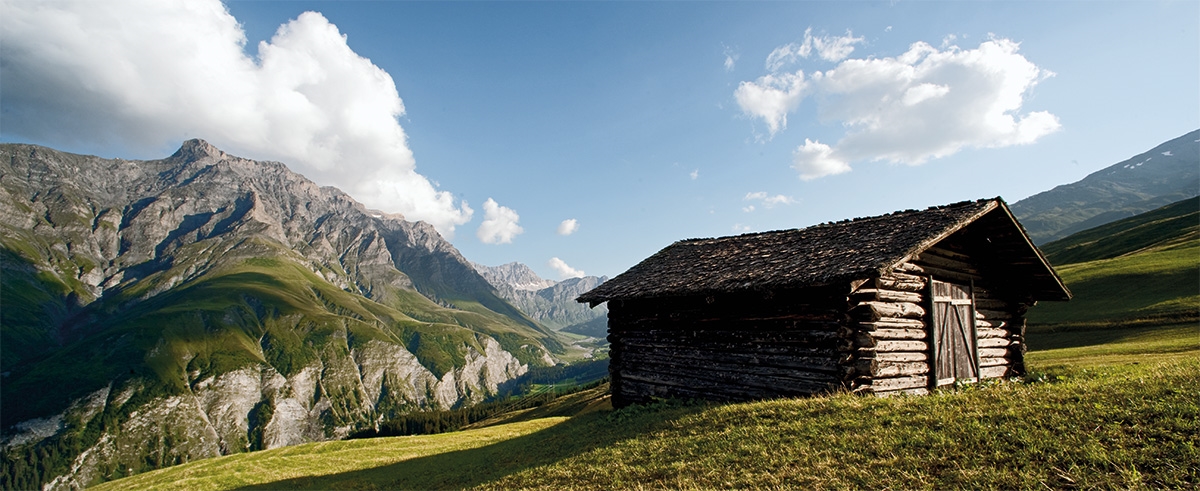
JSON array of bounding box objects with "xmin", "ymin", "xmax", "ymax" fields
[{"xmin": 0, "ymin": 140, "xmax": 562, "ymax": 489}]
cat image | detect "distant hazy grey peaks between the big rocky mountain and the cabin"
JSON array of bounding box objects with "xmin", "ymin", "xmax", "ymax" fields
[{"xmin": 475, "ymin": 263, "xmax": 608, "ymax": 337}]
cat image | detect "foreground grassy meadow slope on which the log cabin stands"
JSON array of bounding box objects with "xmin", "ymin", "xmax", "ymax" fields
[{"xmin": 96, "ymin": 328, "xmax": 1200, "ymax": 490}]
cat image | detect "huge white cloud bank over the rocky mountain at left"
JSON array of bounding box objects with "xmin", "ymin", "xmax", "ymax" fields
[{"xmin": 0, "ymin": 0, "xmax": 472, "ymax": 236}]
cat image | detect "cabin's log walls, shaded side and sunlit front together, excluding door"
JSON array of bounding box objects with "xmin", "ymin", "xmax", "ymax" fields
[{"xmin": 608, "ymin": 223, "xmax": 1032, "ymax": 407}]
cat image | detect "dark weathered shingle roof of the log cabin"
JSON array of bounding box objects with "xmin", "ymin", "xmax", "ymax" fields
[{"xmin": 576, "ymin": 198, "xmax": 1061, "ymax": 305}]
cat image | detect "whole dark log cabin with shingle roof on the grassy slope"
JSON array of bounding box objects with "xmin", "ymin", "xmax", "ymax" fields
[{"xmin": 577, "ymin": 198, "xmax": 1070, "ymax": 407}]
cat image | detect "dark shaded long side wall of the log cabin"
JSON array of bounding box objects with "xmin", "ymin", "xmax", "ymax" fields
[{"xmin": 608, "ymin": 289, "xmax": 852, "ymax": 407}]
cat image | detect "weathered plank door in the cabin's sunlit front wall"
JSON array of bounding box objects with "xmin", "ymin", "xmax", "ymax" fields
[{"xmin": 930, "ymin": 279, "xmax": 979, "ymax": 387}]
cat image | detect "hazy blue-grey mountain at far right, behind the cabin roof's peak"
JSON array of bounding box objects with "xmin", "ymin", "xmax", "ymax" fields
[{"xmin": 1010, "ymin": 130, "xmax": 1200, "ymax": 245}]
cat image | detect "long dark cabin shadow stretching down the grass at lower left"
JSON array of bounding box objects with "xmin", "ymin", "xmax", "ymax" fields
[{"xmin": 232, "ymin": 406, "xmax": 703, "ymax": 491}]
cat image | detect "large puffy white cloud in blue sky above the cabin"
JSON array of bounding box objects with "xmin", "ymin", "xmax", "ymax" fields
[{"xmin": 734, "ymin": 38, "xmax": 1061, "ymax": 179}]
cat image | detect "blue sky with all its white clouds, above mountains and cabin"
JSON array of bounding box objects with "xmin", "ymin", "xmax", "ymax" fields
[{"xmin": 0, "ymin": 0, "xmax": 1200, "ymax": 279}]
